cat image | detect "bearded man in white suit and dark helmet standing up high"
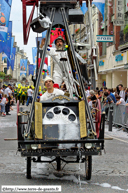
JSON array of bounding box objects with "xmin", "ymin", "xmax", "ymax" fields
[{"xmin": 40, "ymin": 36, "xmax": 73, "ymax": 95}]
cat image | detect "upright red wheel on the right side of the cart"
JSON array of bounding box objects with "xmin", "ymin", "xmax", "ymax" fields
[{"xmin": 95, "ymin": 99, "xmax": 101, "ymax": 138}]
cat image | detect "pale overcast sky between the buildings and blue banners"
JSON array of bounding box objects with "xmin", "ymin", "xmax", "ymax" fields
[{"xmin": 10, "ymin": 0, "xmax": 41, "ymax": 64}]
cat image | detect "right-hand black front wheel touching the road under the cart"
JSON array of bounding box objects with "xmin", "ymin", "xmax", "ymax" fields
[{"xmin": 85, "ymin": 156, "xmax": 92, "ymax": 180}]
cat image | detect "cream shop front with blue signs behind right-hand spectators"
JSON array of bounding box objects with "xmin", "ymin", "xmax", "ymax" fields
[{"xmin": 98, "ymin": 46, "xmax": 128, "ymax": 88}]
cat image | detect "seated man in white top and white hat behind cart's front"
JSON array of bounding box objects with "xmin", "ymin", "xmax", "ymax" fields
[{"xmin": 40, "ymin": 76, "xmax": 64, "ymax": 102}]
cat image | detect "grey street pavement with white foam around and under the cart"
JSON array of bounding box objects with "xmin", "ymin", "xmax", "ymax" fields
[{"xmin": 0, "ymin": 106, "xmax": 128, "ymax": 193}]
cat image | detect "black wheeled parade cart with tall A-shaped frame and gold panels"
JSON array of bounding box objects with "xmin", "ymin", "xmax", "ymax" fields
[{"xmin": 17, "ymin": 0, "xmax": 105, "ymax": 180}]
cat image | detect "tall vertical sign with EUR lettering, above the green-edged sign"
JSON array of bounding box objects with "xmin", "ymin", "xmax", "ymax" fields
[{"xmin": 113, "ymin": 0, "xmax": 125, "ymax": 26}]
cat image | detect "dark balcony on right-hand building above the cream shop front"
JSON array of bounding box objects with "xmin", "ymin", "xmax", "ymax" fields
[{"xmin": 118, "ymin": 30, "xmax": 128, "ymax": 52}]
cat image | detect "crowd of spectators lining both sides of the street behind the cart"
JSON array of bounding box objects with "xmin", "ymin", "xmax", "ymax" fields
[{"xmin": 0, "ymin": 82, "xmax": 128, "ymax": 116}]
